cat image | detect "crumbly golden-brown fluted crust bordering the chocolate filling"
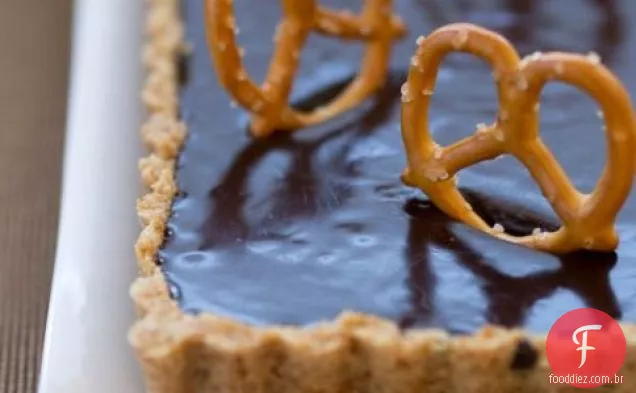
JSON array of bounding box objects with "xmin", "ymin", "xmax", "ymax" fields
[{"xmin": 129, "ymin": 0, "xmax": 636, "ymax": 393}]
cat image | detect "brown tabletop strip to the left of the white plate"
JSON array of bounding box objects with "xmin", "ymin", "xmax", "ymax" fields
[{"xmin": 0, "ymin": 0, "xmax": 71, "ymax": 393}]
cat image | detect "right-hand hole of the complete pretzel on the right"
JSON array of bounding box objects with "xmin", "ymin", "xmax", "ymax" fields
[{"xmin": 539, "ymin": 82, "xmax": 607, "ymax": 193}]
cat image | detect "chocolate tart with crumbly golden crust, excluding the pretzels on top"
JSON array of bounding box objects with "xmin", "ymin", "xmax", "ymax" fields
[{"xmin": 129, "ymin": 0, "xmax": 636, "ymax": 393}]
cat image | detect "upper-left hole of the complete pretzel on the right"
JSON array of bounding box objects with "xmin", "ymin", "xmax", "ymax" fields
[{"xmin": 428, "ymin": 53, "xmax": 499, "ymax": 146}]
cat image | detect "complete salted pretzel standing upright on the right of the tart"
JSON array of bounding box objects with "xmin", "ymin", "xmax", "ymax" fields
[{"xmin": 402, "ymin": 24, "xmax": 636, "ymax": 254}]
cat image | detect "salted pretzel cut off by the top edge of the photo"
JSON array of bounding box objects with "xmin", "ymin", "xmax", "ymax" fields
[{"xmin": 206, "ymin": 0, "xmax": 406, "ymax": 137}]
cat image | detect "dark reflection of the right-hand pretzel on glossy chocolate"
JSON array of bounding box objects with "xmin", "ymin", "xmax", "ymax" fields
[{"xmin": 402, "ymin": 197, "xmax": 621, "ymax": 326}]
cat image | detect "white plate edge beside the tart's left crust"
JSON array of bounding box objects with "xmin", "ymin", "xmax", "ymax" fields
[{"xmin": 39, "ymin": 0, "xmax": 143, "ymax": 393}]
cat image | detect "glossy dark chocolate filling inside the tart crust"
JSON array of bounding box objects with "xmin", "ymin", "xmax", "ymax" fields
[{"xmin": 159, "ymin": 0, "xmax": 636, "ymax": 332}]
